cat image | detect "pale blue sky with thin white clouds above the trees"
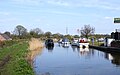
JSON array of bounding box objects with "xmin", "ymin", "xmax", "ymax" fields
[{"xmin": 0, "ymin": 0, "xmax": 120, "ymax": 35}]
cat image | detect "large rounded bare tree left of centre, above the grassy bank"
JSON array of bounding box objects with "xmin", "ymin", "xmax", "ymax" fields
[{"xmin": 14, "ymin": 25, "xmax": 27, "ymax": 37}]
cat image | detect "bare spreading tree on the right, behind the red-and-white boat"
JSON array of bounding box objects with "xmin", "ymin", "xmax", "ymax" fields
[{"xmin": 80, "ymin": 25, "xmax": 95, "ymax": 38}]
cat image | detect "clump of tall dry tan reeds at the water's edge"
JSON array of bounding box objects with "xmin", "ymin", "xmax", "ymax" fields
[{"xmin": 27, "ymin": 38, "xmax": 44, "ymax": 66}]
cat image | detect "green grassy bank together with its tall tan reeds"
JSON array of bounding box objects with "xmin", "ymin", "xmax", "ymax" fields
[{"xmin": 0, "ymin": 38, "xmax": 43, "ymax": 75}]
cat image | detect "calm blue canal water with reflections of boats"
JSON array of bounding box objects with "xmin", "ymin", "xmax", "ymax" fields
[{"xmin": 34, "ymin": 43, "xmax": 120, "ymax": 75}]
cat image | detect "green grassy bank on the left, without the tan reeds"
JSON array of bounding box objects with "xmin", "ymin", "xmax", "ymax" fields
[{"xmin": 0, "ymin": 42, "xmax": 34, "ymax": 75}]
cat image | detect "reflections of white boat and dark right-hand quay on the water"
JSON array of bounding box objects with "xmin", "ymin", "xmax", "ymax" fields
[{"xmin": 71, "ymin": 46, "xmax": 120, "ymax": 67}]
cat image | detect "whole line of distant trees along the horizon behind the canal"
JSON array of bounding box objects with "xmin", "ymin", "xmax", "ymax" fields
[{"xmin": 1, "ymin": 25, "xmax": 110, "ymax": 40}]
